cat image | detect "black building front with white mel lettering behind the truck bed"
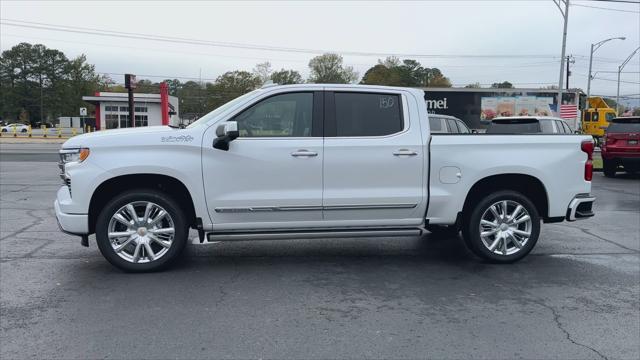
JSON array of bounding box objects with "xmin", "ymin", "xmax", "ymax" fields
[{"xmin": 424, "ymin": 88, "xmax": 580, "ymax": 129}]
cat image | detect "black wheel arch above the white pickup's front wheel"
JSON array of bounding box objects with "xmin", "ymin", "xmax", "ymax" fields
[{"xmin": 89, "ymin": 174, "xmax": 197, "ymax": 233}]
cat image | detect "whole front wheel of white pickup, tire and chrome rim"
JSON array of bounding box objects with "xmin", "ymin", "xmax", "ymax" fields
[{"xmin": 96, "ymin": 189, "xmax": 189, "ymax": 272}]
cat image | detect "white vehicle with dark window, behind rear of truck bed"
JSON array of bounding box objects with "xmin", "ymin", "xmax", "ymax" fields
[{"xmin": 486, "ymin": 116, "xmax": 574, "ymax": 134}]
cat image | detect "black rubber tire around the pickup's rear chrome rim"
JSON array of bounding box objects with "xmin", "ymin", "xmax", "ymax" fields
[{"xmin": 462, "ymin": 190, "xmax": 541, "ymax": 263}]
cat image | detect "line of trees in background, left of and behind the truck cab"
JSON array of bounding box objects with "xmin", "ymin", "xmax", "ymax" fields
[{"xmin": 0, "ymin": 43, "xmax": 451, "ymax": 125}]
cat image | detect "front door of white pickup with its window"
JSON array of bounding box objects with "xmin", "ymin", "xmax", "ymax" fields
[{"xmin": 202, "ymin": 92, "xmax": 324, "ymax": 230}]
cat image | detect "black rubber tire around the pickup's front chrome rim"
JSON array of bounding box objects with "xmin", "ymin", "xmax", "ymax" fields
[{"xmin": 96, "ymin": 189, "xmax": 189, "ymax": 272}]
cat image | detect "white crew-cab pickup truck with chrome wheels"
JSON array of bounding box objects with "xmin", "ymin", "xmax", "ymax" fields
[{"xmin": 55, "ymin": 84, "xmax": 595, "ymax": 271}]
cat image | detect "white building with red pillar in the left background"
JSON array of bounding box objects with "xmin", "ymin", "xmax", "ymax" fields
[{"xmin": 82, "ymin": 86, "xmax": 179, "ymax": 130}]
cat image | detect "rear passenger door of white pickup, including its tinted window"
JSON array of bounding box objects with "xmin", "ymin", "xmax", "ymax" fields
[{"xmin": 323, "ymin": 89, "xmax": 426, "ymax": 226}]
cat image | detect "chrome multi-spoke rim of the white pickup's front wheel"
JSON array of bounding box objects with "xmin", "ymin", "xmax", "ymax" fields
[{"xmin": 108, "ymin": 201, "xmax": 175, "ymax": 263}]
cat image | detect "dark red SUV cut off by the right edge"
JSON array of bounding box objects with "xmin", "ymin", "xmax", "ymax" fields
[{"xmin": 600, "ymin": 116, "xmax": 640, "ymax": 177}]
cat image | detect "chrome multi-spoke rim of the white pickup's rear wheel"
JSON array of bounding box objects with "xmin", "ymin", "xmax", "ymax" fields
[{"xmin": 479, "ymin": 200, "xmax": 533, "ymax": 255}]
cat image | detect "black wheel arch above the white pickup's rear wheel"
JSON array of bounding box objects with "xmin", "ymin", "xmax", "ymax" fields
[{"xmin": 462, "ymin": 173, "xmax": 549, "ymax": 221}]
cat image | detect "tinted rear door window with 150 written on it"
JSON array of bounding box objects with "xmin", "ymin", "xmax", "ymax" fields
[{"xmin": 334, "ymin": 92, "xmax": 404, "ymax": 136}]
